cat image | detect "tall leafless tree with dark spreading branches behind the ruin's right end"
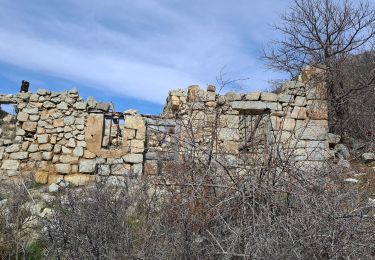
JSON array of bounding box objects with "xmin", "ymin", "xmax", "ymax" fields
[{"xmin": 265, "ymin": 0, "xmax": 375, "ymax": 137}]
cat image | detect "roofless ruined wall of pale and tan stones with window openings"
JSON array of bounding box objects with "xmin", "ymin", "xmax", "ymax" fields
[{"xmin": 0, "ymin": 69, "xmax": 332, "ymax": 185}]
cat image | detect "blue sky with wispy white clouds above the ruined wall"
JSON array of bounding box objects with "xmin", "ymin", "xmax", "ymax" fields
[{"xmin": 0, "ymin": 0, "xmax": 290, "ymax": 114}]
